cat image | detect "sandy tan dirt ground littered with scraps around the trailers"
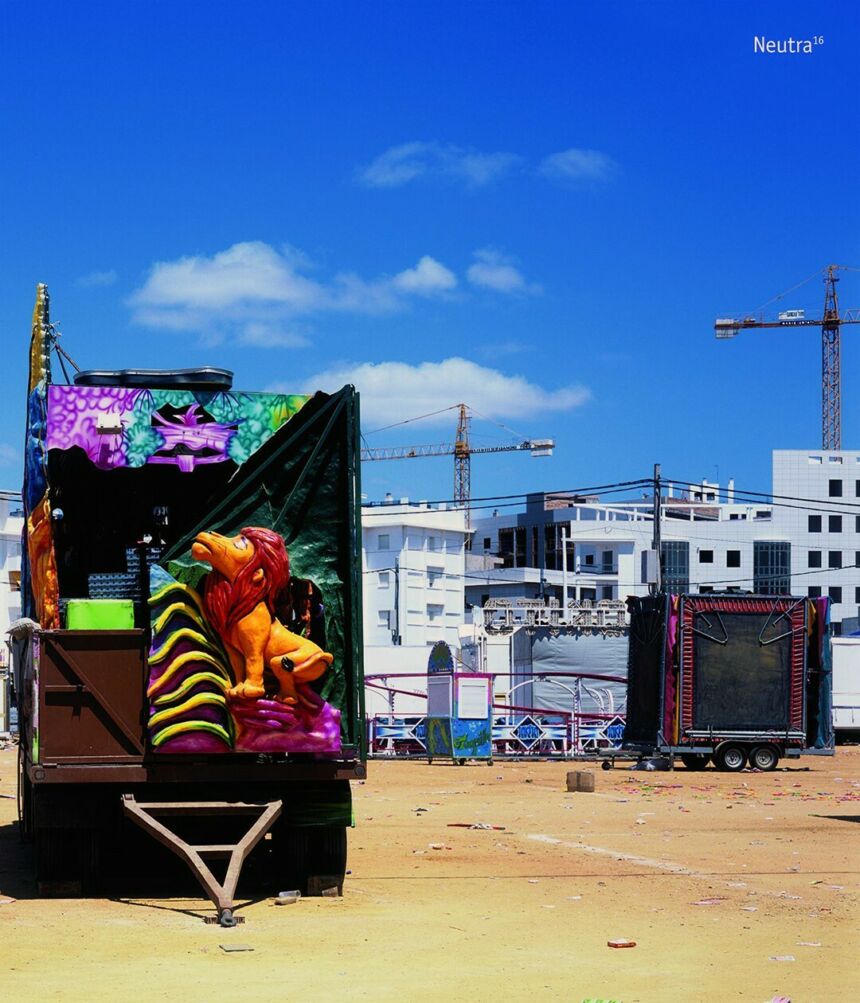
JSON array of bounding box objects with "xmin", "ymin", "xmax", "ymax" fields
[{"xmin": 0, "ymin": 748, "xmax": 860, "ymax": 1003}]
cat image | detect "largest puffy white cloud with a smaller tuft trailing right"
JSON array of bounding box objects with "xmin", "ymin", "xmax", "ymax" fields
[{"xmin": 128, "ymin": 241, "xmax": 457, "ymax": 347}]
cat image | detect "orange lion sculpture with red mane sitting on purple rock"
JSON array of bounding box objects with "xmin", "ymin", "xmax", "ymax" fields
[{"xmin": 191, "ymin": 527, "xmax": 333, "ymax": 704}]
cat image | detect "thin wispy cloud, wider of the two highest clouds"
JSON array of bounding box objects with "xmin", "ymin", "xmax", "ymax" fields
[{"xmin": 358, "ymin": 142, "xmax": 522, "ymax": 188}]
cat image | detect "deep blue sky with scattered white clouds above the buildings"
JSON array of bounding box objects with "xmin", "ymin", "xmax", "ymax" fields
[{"xmin": 0, "ymin": 0, "xmax": 860, "ymax": 498}]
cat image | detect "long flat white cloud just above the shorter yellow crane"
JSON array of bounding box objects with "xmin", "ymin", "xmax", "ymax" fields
[{"xmin": 289, "ymin": 358, "xmax": 591, "ymax": 427}]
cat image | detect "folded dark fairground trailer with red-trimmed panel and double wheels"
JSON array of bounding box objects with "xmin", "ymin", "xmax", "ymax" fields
[{"xmin": 623, "ymin": 594, "xmax": 834, "ymax": 772}]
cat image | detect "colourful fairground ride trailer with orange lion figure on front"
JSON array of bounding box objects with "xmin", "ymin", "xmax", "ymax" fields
[{"xmin": 11, "ymin": 286, "xmax": 366, "ymax": 926}]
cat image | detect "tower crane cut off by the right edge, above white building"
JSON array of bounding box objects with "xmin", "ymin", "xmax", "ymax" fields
[{"xmin": 713, "ymin": 265, "xmax": 860, "ymax": 449}]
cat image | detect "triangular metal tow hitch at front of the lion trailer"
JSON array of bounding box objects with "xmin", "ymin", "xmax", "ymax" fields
[{"xmin": 122, "ymin": 794, "xmax": 283, "ymax": 927}]
